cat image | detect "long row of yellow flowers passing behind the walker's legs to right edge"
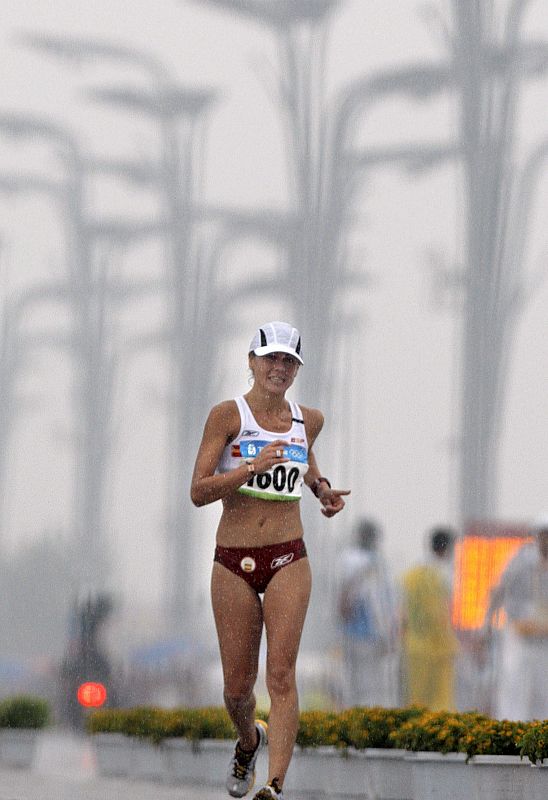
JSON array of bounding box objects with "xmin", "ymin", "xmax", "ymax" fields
[{"xmin": 87, "ymin": 706, "xmax": 548, "ymax": 763}]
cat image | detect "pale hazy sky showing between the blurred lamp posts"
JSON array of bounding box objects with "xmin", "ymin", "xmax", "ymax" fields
[{"xmin": 0, "ymin": 0, "xmax": 548, "ymax": 624}]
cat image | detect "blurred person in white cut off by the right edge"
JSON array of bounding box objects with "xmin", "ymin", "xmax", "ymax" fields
[{"xmin": 485, "ymin": 515, "xmax": 548, "ymax": 720}]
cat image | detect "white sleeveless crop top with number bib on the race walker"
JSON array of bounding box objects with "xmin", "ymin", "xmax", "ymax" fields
[{"xmin": 217, "ymin": 397, "xmax": 308, "ymax": 500}]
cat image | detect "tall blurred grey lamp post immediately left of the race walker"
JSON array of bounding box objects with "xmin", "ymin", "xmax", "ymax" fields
[{"xmin": 20, "ymin": 34, "xmax": 224, "ymax": 634}]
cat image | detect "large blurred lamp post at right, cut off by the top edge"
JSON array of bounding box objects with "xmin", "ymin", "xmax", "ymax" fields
[{"xmin": 336, "ymin": 6, "xmax": 548, "ymax": 525}]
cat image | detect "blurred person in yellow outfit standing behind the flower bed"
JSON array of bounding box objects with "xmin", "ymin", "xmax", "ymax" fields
[{"xmin": 402, "ymin": 527, "xmax": 458, "ymax": 711}]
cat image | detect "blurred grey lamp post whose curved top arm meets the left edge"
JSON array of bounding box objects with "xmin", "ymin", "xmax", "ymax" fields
[{"xmin": 0, "ymin": 113, "xmax": 134, "ymax": 585}]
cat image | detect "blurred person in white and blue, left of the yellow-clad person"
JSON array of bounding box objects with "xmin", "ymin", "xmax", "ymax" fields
[{"xmin": 338, "ymin": 519, "xmax": 398, "ymax": 707}]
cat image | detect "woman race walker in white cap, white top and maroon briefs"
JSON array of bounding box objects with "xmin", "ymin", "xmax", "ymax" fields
[{"xmin": 191, "ymin": 322, "xmax": 349, "ymax": 800}]
